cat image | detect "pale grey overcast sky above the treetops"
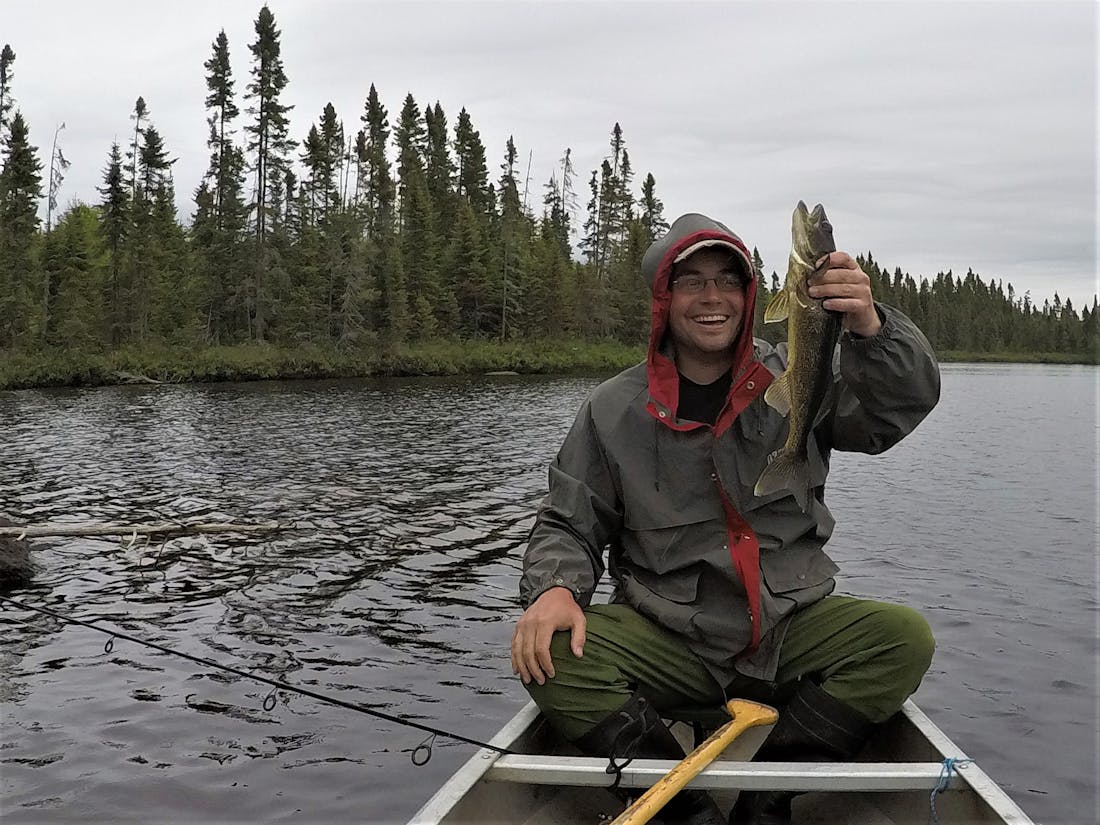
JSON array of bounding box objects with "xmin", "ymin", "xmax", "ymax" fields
[{"xmin": 0, "ymin": 0, "xmax": 1098, "ymax": 309}]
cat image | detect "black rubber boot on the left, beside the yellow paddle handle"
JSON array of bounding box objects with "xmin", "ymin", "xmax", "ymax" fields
[{"xmin": 574, "ymin": 693, "xmax": 726, "ymax": 825}]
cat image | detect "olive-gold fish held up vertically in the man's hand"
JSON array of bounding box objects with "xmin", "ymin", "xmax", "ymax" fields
[{"xmin": 754, "ymin": 200, "xmax": 842, "ymax": 513}]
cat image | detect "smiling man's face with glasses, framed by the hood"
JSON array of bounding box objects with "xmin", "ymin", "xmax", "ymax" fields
[{"xmin": 669, "ymin": 248, "xmax": 745, "ymax": 360}]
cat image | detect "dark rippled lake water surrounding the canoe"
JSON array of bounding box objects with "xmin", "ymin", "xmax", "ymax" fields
[{"xmin": 0, "ymin": 364, "xmax": 1100, "ymax": 825}]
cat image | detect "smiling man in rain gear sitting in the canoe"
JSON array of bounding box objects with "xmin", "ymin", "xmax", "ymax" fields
[{"xmin": 512, "ymin": 215, "xmax": 939, "ymax": 825}]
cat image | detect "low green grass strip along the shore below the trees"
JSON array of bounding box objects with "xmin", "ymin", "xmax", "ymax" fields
[{"xmin": 0, "ymin": 340, "xmax": 1098, "ymax": 389}]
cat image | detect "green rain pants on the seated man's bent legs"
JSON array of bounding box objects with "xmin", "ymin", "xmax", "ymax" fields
[{"xmin": 526, "ymin": 596, "xmax": 935, "ymax": 740}]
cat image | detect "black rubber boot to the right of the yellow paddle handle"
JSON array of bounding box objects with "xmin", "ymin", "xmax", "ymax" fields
[{"xmin": 729, "ymin": 679, "xmax": 875, "ymax": 825}]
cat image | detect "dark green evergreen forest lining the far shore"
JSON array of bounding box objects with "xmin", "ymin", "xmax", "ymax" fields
[{"xmin": 0, "ymin": 7, "xmax": 1100, "ymax": 387}]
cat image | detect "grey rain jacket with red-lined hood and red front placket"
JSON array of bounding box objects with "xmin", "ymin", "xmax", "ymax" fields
[{"xmin": 520, "ymin": 215, "xmax": 939, "ymax": 685}]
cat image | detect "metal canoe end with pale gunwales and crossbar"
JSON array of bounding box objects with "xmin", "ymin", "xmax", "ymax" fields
[{"xmin": 408, "ymin": 700, "xmax": 1034, "ymax": 825}]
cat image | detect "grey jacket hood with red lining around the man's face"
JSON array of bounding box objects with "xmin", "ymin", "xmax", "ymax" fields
[{"xmin": 641, "ymin": 212, "xmax": 771, "ymax": 429}]
